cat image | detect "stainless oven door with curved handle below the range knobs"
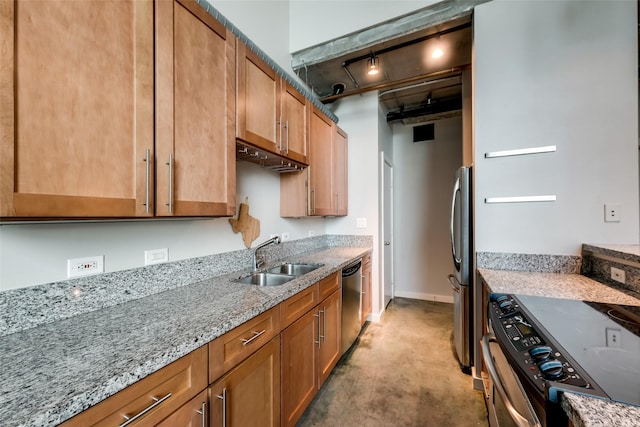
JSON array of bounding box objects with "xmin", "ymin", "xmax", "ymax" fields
[{"xmin": 482, "ymin": 333, "xmax": 541, "ymax": 427}]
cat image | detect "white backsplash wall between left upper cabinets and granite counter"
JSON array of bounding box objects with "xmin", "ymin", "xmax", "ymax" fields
[{"xmin": 0, "ymin": 162, "xmax": 325, "ymax": 291}]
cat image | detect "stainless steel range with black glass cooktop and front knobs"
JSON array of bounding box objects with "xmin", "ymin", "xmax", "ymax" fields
[{"xmin": 483, "ymin": 294, "xmax": 640, "ymax": 426}]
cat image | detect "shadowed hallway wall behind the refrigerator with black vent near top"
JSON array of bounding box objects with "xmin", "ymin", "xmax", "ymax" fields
[{"xmin": 393, "ymin": 117, "xmax": 462, "ymax": 302}]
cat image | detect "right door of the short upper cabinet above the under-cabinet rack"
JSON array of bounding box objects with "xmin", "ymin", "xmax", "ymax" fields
[{"xmin": 281, "ymin": 80, "xmax": 309, "ymax": 164}]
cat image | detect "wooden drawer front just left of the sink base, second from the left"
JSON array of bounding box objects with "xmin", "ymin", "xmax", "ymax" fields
[{"xmin": 209, "ymin": 306, "xmax": 280, "ymax": 383}]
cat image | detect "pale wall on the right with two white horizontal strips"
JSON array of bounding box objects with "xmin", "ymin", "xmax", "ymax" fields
[{"xmin": 474, "ymin": 0, "xmax": 639, "ymax": 255}]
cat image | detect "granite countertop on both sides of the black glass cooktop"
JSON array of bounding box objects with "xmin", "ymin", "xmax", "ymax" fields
[{"xmin": 478, "ymin": 269, "xmax": 640, "ymax": 427}]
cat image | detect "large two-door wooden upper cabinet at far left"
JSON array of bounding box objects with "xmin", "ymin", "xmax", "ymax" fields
[{"xmin": 0, "ymin": 0, "xmax": 235, "ymax": 219}]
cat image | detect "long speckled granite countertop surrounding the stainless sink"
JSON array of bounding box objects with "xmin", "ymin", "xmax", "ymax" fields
[{"xmin": 0, "ymin": 247, "xmax": 371, "ymax": 427}]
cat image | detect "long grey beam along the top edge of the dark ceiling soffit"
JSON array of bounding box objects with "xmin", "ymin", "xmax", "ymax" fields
[{"xmin": 291, "ymin": 0, "xmax": 490, "ymax": 69}]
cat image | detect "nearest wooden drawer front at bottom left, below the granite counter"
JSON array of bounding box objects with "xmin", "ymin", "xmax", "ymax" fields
[{"xmin": 62, "ymin": 346, "xmax": 207, "ymax": 427}]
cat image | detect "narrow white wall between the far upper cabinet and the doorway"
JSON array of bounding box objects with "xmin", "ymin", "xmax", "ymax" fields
[{"xmin": 326, "ymin": 92, "xmax": 382, "ymax": 316}]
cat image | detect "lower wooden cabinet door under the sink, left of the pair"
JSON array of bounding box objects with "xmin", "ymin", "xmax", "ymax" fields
[{"xmin": 281, "ymin": 308, "xmax": 320, "ymax": 426}]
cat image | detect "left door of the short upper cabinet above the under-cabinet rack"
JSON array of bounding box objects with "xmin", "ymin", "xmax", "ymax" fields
[{"xmin": 236, "ymin": 41, "xmax": 282, "ymax": 153}]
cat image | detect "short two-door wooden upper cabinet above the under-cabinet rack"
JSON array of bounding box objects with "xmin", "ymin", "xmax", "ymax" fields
[{"xmin": 236, "ymin": 41, "xmax": 309, "ymax": 164}]
